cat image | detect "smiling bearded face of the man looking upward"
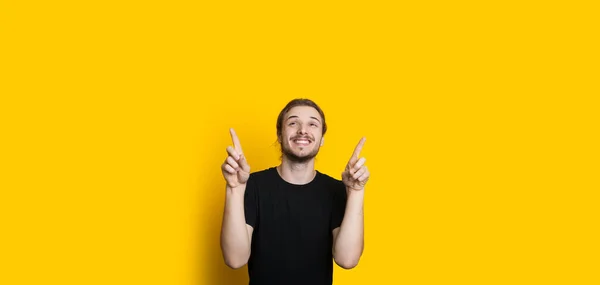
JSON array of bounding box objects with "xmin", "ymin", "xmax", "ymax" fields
[{"xmin": 279, "ymin": 106, "xmax": 323, "ymax": 162}]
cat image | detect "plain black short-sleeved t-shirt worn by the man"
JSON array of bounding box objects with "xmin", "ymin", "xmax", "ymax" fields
[{"xmin": 245, "ymin": 167, "xmax": 346, "ymax": 285}]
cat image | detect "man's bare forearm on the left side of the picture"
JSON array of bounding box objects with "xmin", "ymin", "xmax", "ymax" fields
[{"xmin": 221, "ymin": 185, "xmax": 250, "ymax": 268}]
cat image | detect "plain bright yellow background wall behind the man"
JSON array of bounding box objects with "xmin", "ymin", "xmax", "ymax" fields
[{"xmin": 0, "ymin": 0, "xmax": 600, "ymax": 285}]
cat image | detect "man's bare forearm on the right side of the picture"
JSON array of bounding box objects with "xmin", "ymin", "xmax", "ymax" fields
[{"xmin": 334, "ymin": 190, "xmax": 365, "ymax": 268}]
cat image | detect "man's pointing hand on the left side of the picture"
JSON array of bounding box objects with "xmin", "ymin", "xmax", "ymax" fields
[{"xmin": 221, "ymin": 129, "xmax": 250, "ymax": 188}]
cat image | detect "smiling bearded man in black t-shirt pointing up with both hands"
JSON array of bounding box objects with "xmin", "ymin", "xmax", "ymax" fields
[{"xmin": 221, "ymin": 99, "xmax": 370, "ymax": 285}]
